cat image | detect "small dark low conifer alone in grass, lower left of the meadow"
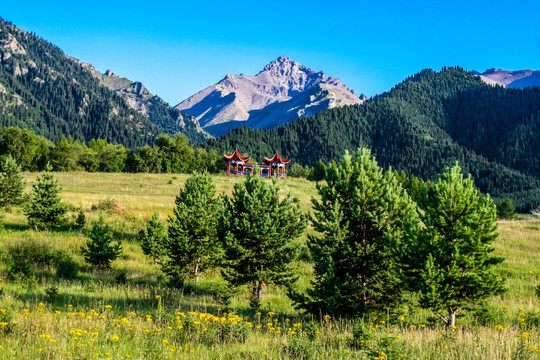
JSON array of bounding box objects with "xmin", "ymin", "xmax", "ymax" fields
[{"xmin": 81, "ymin": 216, "xmax": 122, "ymax": 269}]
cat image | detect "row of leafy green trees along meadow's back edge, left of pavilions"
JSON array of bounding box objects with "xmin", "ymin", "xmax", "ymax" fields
[{"xmin": 0, "ymin": 127, "xmax": 225, "ymax": 173}]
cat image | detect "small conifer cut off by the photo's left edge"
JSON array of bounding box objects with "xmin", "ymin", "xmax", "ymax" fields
[{"xmin": 0, "ymin": 155, "xmax": 25, "ymax": 208}]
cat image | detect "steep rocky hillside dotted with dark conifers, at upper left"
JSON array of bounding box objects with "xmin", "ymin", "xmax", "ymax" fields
[{"xmin": 0, "ymin": 18, "xmax": 205, "ymax": 148}]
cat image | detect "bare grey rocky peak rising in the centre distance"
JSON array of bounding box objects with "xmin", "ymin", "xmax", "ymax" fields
[{"xmin": 175, "ymin": 56, "xmax": 364, "ymax": 136}]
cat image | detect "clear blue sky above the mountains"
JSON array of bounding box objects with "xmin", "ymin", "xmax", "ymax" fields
[{"xmin": 0, "ymin": 0, "xmax": 540, "ymax": 105}]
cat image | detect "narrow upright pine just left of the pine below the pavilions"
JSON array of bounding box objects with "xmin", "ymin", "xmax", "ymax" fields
[{"xmin": 164, "ymin": 172, "xmax": 223, "ymax": 281}]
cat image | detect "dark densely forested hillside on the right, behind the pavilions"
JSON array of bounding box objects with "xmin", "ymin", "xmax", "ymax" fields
[{"xmin": 207, "ymin": 68, "xmax": 540, "ymax": 211}]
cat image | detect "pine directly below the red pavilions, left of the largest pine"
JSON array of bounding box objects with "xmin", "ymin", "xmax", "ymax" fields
[{"xmin": 218, "ymin": 177, "xmax": 307, "ymax": 299}]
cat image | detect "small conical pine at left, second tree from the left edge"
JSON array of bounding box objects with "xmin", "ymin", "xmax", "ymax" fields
[{"xmin": 24, "ymin": 164, "xmax": 68, "ymax": 230}]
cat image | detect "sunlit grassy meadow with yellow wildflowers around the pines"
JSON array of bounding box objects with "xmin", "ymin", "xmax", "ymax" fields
[{"xmin": 0, "ymin": 173, "xmax": 540, "ymax": 359}]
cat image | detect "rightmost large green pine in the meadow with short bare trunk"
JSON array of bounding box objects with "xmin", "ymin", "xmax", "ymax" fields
[{"xmin": 411, "ymin": 164, "xmax": 504, "ymax": 325}]
